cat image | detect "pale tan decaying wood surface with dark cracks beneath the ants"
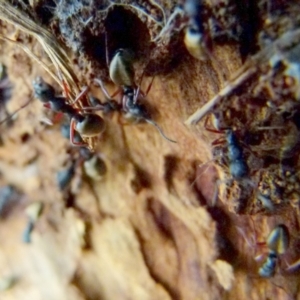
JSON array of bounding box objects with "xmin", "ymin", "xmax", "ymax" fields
[{"xmin": 0, "ymin": 1, "xmax": 300, "ymax": 300}]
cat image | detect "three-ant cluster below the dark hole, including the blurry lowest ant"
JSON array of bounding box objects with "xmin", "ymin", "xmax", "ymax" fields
[{"xmin": 29, "ymin": 45, "xmax": 175, "ymax": 209}]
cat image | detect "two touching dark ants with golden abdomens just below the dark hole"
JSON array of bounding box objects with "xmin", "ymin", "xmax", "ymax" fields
[{"xmin": 33, "ymin": 49, "xmax": 175, "ymax": 146}]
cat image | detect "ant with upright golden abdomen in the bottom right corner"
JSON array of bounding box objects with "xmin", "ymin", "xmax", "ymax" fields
[{"xmin": 258, "ymin": 224, "xmax": 290, "ymax": 278}]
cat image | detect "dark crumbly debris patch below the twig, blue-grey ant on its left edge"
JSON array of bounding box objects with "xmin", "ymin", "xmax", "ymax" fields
[{"xmin": 205, "ymin": 38, "xmax": 300, "ymax": 214}]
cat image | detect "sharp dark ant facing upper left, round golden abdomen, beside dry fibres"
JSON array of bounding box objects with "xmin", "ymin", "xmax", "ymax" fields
[{"xmin": 33, "ymin": 77, "xmax": 105, "ymax": 146}]
